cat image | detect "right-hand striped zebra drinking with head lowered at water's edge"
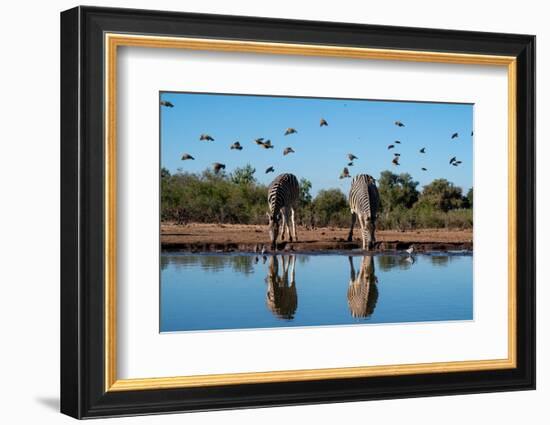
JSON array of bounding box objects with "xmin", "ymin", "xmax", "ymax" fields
[{"xmin": 348, "ymin": 174, "xmax": 380, "ymax": 249}]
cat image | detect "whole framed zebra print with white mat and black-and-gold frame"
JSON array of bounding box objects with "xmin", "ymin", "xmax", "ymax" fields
[{"xmin": 61, "ymin": 7, "xmax": 535, "ymax": 418}]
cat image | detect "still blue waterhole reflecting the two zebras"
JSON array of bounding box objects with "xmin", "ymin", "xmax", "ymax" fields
[{"xmin": 160, "ymin": 253, "xmax": 473, "ymax": 332}]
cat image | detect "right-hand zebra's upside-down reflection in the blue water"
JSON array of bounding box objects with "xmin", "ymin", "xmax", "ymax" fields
[{"xmin": 348, "ymin": 255, "xmax": 378, "ymax": 318}]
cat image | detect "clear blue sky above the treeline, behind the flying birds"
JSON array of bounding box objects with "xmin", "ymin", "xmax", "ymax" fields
[{"xmin": 160, "ymin": 92, "xmax": 473, "ymax": 195}]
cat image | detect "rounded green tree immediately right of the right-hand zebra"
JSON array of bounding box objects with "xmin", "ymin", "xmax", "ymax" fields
[{"xmin": 378, "ymin": 170, "xmax": 418, "ymax": 212}]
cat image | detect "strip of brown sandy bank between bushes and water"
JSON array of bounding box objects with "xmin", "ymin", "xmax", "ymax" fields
[{"xmin": 160, "ymin": 223, "xmax": 473, "ymax": 252}]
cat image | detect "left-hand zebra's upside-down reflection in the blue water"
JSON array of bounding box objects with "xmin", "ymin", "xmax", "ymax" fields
[{"xmin": 266, "ymin": 255, "xmax": 298, "ymax": 320}]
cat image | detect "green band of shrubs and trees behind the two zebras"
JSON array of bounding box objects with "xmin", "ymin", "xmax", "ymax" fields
[{"xmin": 161, "ymin": 165, "xmax": 473, "ymax": 230}]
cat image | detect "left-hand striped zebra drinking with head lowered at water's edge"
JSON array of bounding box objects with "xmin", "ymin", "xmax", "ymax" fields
[{"xmin": 267, "ymin": 174, "xmax": 300, "ymax": 249}]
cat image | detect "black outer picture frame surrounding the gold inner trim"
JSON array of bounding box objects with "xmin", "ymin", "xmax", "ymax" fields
[{"xmin": 61, "ymin": 7, "xmax": 535, "ymax": 418}]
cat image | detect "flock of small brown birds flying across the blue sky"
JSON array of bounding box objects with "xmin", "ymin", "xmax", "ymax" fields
[{"xmin": 160, "ymin": 100, "xmax": 474, "ymax": 179}]
